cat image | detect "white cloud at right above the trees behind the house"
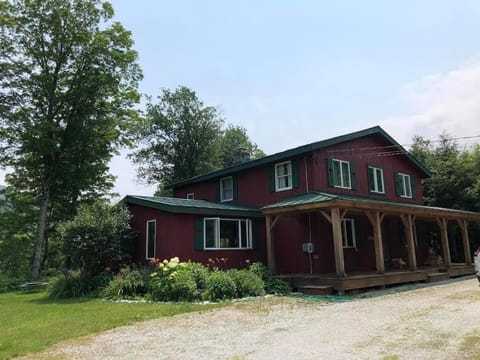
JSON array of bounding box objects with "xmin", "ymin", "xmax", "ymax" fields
[{"xmin": 381, "ymin": 61, "xmax": 480, "ymax": 143}]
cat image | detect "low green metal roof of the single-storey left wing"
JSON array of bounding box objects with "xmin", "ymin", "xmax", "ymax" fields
[{"xmin": 122, "ymin": 195, "xmax": 263, "ymax": 217}]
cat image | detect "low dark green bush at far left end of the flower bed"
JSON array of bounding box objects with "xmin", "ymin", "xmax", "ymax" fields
[{"xmin": 47, "ymin": 271, "xmax": 111, "ymax": 299}]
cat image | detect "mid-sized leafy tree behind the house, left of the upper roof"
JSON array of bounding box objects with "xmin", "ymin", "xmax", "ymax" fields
[{"xmin": 132, "ymin": 86, "xmax": 223, "ymax": 190}]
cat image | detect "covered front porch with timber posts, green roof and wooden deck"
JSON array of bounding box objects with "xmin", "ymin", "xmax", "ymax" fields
[{"xmin": 263, "ymin": 192, "xmax": 480, "ymax": 292}]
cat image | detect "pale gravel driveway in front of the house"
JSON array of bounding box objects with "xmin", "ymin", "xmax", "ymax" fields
[{"xmin": 25, "ymin": 277, "xmax": 480, "ymax": 360}]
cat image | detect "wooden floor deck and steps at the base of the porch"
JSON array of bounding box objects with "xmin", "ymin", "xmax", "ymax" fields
[{"xmin": 279, "ymin": 264, "xmax": 475, "ymax": 293}]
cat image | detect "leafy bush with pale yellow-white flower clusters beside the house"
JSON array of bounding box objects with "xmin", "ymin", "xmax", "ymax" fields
[{"xmin": 150, "ymin": 257, "xmax": 202, "ymax": 301}]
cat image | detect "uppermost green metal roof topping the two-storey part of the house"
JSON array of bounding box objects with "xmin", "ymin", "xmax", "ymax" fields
[{"xmin": 169, "ymin": 126, "xmax": 430, "ymax": 188}]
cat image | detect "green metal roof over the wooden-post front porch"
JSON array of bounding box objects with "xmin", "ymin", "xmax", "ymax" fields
[{"xmin": 262, "ymin": 191, "xmax": 480, "ymax": 222}]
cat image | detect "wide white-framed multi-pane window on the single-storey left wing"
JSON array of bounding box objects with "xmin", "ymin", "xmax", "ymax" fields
[{"xmin": 204, "ymin": 218, "xmax": 252, "ymax": 249}]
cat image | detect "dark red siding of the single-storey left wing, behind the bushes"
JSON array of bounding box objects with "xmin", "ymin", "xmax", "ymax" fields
[{"xmin": 130, "ymin": 205, "xmax": 266, "ymax": 268}]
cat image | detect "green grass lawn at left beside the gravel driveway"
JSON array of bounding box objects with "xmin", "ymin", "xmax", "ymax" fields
[{"xmin": 0, "ymin": 292, "xmax": 219, "ymax": 359}]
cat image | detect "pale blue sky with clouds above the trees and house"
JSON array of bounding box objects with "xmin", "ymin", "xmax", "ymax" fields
[{"xmin": 0, "ymin": 0, "xmax": 480, "ymax": 195}]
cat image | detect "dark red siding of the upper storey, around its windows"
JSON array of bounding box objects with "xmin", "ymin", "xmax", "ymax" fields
[{"xmin": 174, "ymin": 135, "xmax": 423, "ymax": 206}]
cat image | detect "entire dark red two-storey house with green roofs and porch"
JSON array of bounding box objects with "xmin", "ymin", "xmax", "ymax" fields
[{"xmin": 125, "ymin": 127, "xmax": 480, "ymax": 291}]
